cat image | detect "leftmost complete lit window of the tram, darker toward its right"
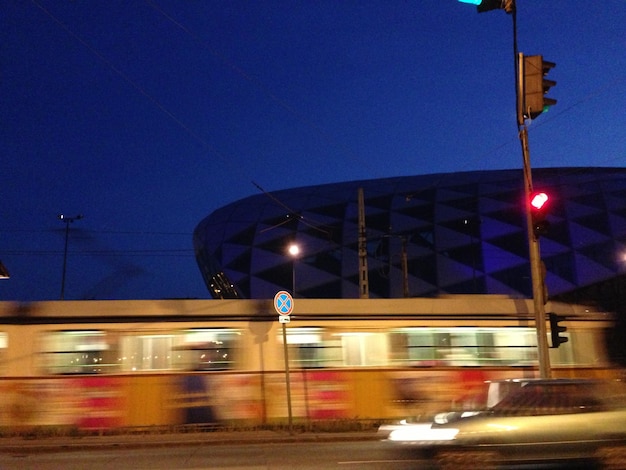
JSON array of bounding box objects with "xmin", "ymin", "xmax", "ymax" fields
[{"xmin": 41, "ymin": 330, "xmax": 118, "ymax": 374}]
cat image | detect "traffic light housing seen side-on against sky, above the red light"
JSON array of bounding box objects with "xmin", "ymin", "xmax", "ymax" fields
[{"xmin": 522, "ymin": 55, "xmax": 556, "ymax": 119}]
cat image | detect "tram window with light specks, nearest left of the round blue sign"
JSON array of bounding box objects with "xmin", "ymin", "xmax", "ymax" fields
[{"xmin": 173, "ymin": 329, "xmax": 241, "ymax": 370}]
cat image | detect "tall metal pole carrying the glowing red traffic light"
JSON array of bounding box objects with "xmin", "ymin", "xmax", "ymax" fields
[{"xmin": 516, "ymin": 53, "xmax": 551, "ymax": 379}]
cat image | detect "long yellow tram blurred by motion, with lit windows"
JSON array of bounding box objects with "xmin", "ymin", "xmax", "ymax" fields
[{"xmin": 0, "ymin": 296, "xmax": 617, "ymax": 429}]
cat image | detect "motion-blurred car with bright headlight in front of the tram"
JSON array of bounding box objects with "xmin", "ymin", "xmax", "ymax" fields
[{"xmin": 381, "ymin": 379, "xmax": 626, "ymax": 470}]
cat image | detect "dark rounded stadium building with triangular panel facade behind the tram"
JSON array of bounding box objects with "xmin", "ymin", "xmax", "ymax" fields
[{"xmin": 194, "ymin": 168, "xmax": 626, "ymax": 302}]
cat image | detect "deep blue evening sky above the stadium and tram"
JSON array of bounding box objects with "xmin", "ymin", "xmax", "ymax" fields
[{"xmin": 0, "ymin": 0, "xmax": 626, "ymax": 301}]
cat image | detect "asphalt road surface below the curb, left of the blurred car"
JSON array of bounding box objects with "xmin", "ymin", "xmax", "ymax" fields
[{"xmin": 0, "ymin": 440, "xmax": 424, "ymax": 470}]
